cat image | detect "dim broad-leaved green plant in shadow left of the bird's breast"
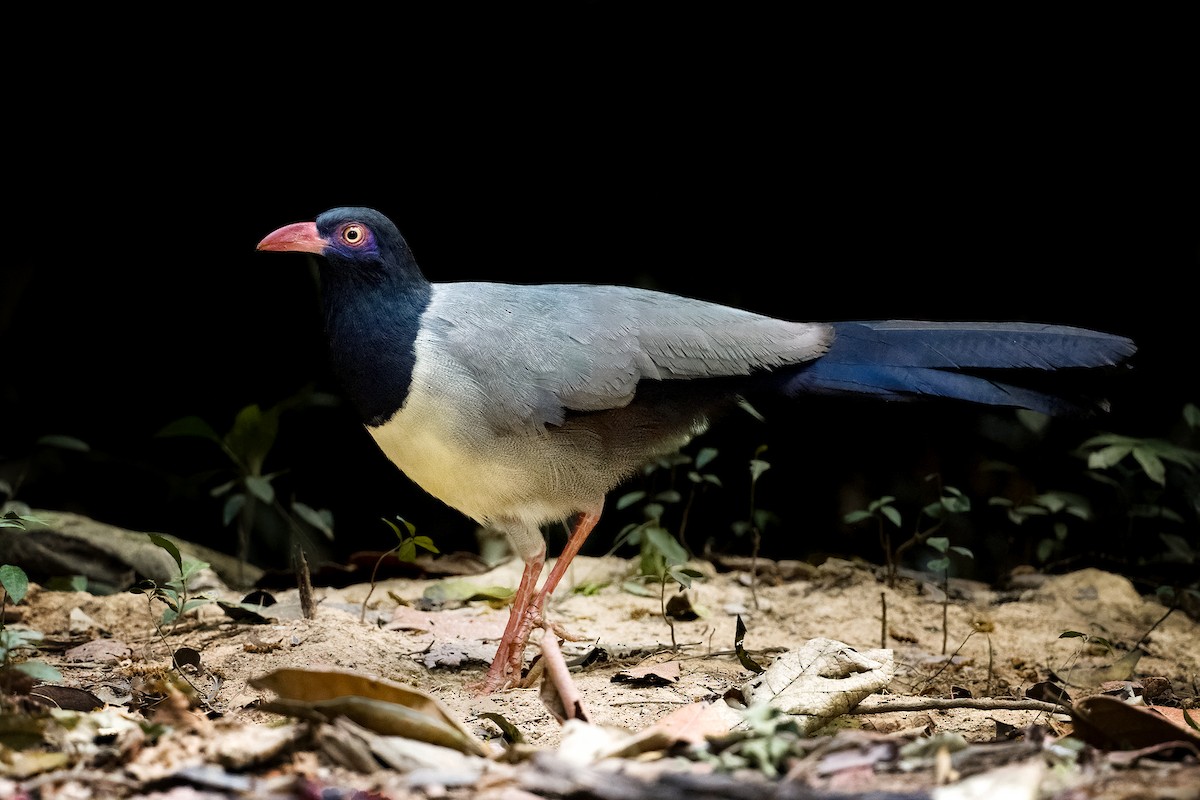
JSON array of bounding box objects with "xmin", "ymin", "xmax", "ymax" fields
[{"xmin": 157, "ymin": 390, "xmax": 334, "ymax": 578}]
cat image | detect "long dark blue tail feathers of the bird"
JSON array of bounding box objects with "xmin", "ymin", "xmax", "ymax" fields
[{"xmin": 784, "ymin": 320, "xmax": 1136, "ymax": 414}]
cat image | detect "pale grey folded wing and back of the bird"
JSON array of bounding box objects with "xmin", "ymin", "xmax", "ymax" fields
[{"xmin": 421, "ymin": 283, "xmax": 833, "ymax": 429}]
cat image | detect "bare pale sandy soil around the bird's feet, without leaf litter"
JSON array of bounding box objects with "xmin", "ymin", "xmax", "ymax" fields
[{"xmin": 0, "ymin": 512, "xmax": 1200, "ymax": 798}]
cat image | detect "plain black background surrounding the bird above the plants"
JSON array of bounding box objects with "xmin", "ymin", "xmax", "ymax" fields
[{"xmin": 0, "ymin": 9, "xmax": 1200, "ymax": 585}]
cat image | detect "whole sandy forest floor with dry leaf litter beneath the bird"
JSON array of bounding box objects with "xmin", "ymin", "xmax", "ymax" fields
[{"xmin": 0, "ymin": 512, "xmax": 1200, "ymax": 800}]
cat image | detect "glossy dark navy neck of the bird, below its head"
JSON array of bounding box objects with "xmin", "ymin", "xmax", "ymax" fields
[{"xmin": 323, "ymin": 276, "xmax": 432, "ymax": 426}]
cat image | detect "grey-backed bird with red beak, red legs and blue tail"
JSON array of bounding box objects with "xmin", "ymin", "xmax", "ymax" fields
[{"xmin": 257, "ymin": 206, "xmax": 1136, "ymax": 694}]
